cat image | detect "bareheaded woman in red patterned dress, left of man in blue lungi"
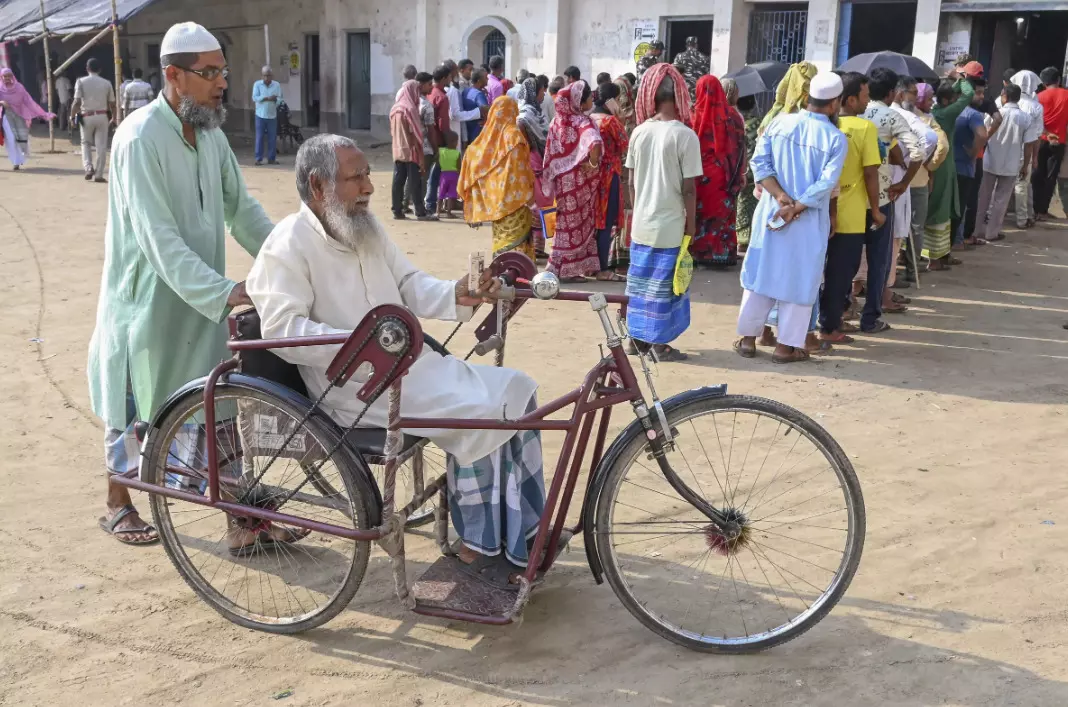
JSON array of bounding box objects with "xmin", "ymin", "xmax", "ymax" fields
[{"xmin": 590, "ymin": 83, "xmax": 629, "ymax": 282}]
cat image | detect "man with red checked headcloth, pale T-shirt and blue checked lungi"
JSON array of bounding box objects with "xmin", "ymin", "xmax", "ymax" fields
[{"xmin": 627, "ymin": 64, "xmax": 704, "ymax": 361}]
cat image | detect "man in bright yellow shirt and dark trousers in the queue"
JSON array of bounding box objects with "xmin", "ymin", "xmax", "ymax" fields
[{"xmin": 819, "ymin": 72, "xmax": 886, "ymax": 344}]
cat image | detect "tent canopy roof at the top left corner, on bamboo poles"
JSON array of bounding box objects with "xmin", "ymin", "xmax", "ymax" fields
[{"xmin": 0, "ymin": 0, "xmax": 154, "ymax": 41}]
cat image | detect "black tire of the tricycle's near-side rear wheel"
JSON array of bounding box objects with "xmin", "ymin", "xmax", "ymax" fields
[{"xmin": 143, "ymin": 382, "xmax": 378, "ymax": 634}]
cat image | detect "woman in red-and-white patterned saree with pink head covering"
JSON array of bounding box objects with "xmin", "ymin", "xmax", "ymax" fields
[{"xmin": 543, "ymin": 81, "xmax": 603, "ymax": 282}]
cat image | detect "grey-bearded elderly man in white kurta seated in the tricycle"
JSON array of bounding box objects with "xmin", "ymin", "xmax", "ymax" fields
[{"xmin": 247, "ymin": 135, "xmax": 545, "ymax": 587}]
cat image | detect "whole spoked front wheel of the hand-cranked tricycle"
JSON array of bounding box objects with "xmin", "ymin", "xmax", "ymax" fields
[{"xmin": 594, "ymin": 394, "xmax": 865, "ymax": 653}]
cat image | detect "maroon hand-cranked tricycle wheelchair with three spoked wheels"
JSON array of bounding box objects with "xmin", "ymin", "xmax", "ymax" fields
[{"xmin": 113, "ymin": 253, "xmax": 865, "ymax": 653}]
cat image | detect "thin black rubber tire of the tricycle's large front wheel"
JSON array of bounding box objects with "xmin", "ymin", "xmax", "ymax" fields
[{"xmin": 593, "ymin": 394, "xmax": 866, "ymax": 654}]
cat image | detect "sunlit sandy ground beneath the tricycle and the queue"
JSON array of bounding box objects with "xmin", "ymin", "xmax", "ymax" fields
[{"xmin": 0, "ymin": 134, "xmax": 1068, "ymax": 707}]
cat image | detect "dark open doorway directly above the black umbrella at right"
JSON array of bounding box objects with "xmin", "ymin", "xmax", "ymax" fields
[{"xmin": 838, "ymin": 1, "xmax": 916, "ymax": 58}]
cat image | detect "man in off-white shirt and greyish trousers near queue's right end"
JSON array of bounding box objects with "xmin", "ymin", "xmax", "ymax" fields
[{"xmin": 972, "ymin": 83, "xmax": 1034, "ymax": 242}]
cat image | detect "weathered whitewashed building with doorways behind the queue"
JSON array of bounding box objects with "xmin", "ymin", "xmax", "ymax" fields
[{"xmin": 6, "ymin": 0, "xmax": 1068, "ymax": 135}]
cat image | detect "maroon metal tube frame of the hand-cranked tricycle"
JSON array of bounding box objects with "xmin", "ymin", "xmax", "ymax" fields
[{"xmin": 111, "ymin": 287, "xmax": 643, "ymax": 581}]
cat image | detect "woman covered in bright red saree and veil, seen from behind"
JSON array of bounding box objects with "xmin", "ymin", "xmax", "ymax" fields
[{"xmin": 690, "ymin": 75, "xmax": 745, "ymax": 266}]
